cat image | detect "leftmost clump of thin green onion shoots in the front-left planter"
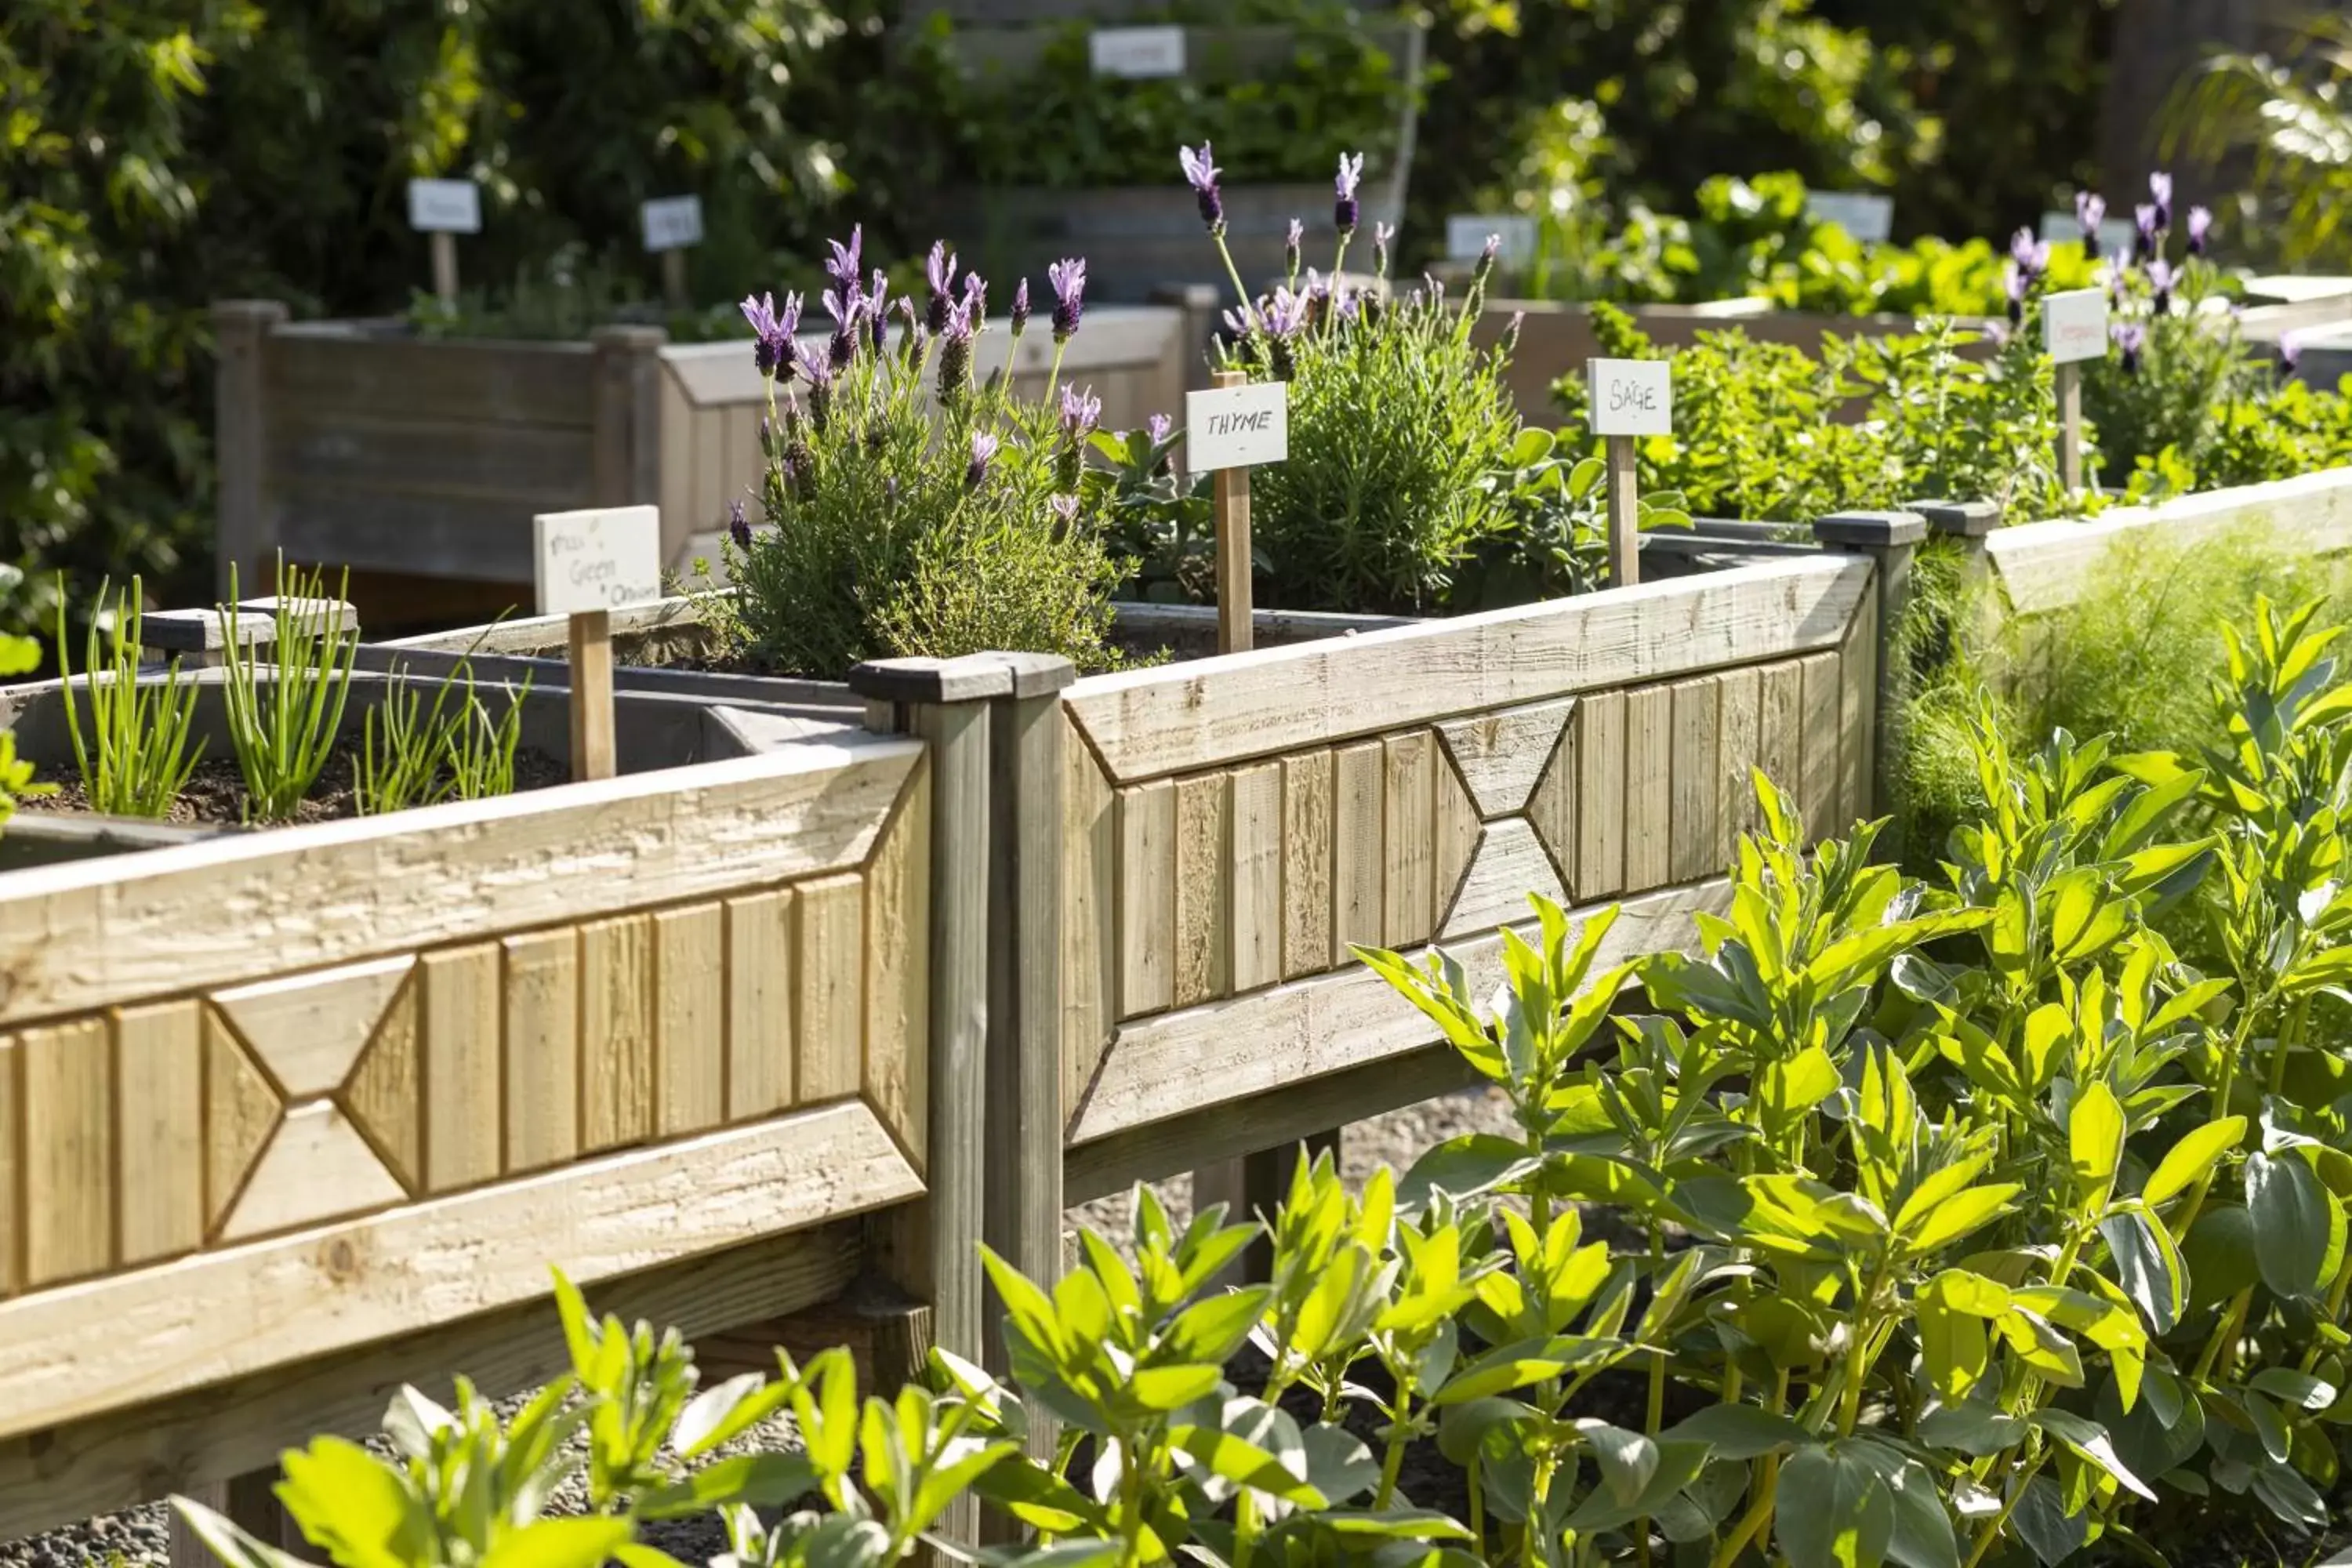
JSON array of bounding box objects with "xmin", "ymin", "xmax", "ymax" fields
[{"xmin": 56, "ymin": 579, "xmax": 205, "ymax": 818}]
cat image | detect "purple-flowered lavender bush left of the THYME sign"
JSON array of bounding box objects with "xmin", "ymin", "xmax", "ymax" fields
[{"xmin": 715, "ymin": 233, "xmax": 1120, "ymax": 675}]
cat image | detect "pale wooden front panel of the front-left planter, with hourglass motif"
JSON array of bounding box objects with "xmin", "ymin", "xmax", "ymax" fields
[{"xmin": 0, "ymin": 739, "xmax": 931, "ymax": 1436}]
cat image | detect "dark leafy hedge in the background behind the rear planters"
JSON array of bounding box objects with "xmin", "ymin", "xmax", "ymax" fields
[{"xmin": 0, "ymin": 0, "xmax": 2114, "ymax": 630}]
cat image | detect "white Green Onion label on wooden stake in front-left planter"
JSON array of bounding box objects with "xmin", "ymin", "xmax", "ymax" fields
[{"xmin": 532, "ymin": 506, "xmax": 661, "ymax": 779}]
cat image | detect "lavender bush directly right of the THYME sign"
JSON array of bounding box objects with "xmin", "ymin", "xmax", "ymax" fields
[{"xmin": 1178, "ymin": 143, "xmax": 1519, "ymax": 612}]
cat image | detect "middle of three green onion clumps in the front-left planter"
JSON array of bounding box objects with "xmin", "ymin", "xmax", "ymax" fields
[{"xmin": 221, "ymin": 560, "xmax": 360, "ymax": 822}]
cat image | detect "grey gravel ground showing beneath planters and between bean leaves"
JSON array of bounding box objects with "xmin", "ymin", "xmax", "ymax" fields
[{"xmin": 0, "ymin": 1088, "xmax": 1510, "ymax": 1568}]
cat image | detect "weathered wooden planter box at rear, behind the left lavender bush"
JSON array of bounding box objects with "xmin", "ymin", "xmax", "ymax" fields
[{"xmin": 214, "ymin": 301, "xmax": 1195, "ymax": 628}]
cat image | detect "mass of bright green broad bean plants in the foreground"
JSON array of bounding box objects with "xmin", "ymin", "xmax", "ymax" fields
[{"xmin": 181, "ymin": 602, "xmax": 2352, "ymax": 1568}]
